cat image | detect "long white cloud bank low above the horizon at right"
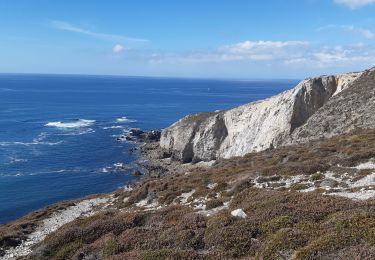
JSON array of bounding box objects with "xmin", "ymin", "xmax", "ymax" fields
[{"xmin": 149, "ymin": 41, "xmax": 375, "ymax": 68}]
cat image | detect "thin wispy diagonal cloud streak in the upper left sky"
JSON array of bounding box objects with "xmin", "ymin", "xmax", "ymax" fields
[{"xmin": 50, "ymin": 20, "xmax": 149, "ymax": 42}]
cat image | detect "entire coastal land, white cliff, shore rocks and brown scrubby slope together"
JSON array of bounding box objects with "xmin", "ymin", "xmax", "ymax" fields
[{"xmin": 0, "ymin": 69, "xmax": 375, "ymax": 260}]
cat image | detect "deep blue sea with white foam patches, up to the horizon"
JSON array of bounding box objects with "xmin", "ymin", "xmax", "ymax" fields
[{"xmin": 0, "ymin": 74, "xmax": 297, "ymax": 223}]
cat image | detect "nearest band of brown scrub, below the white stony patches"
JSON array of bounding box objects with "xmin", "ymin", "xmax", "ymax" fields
[{"xmin": 22, "ymin": 188, "xmax": 375, "ymax": 260}]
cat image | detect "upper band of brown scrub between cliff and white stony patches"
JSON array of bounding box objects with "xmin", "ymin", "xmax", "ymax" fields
[{"xmin": 111, "ymin": 130, "xmax": 375, "ymax": 212}]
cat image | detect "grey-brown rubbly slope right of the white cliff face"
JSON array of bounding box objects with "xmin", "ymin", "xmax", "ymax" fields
[{"xmin": 290, "ymin": 68, "xmax": 375, "ymax": 143}]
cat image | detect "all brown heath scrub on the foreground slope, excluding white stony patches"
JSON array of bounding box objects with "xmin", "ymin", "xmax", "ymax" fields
[{"xmin": 8, "ymin": 130, "xmax": 375, "ymax": 260}]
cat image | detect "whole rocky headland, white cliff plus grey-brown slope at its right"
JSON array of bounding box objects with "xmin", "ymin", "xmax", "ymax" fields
[{"xmin": 160, "ymin": 69, "xmax": 375, "ymax": 163}]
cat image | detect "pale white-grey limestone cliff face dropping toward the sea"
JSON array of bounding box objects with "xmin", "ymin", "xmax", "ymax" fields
[{"xmin": 160, "ymin": 70, "xmax": 362, "ymax": 162}]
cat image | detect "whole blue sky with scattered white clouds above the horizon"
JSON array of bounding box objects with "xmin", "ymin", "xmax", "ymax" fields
[{"xmin": 0, "ymin": 0, "xmax": 375, "ymax": 78}]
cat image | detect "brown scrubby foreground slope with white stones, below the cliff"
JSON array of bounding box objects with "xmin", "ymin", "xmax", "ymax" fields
[{"xmin": 0, "ymin": 130, "xmax": 375, "ymax": 260}]
